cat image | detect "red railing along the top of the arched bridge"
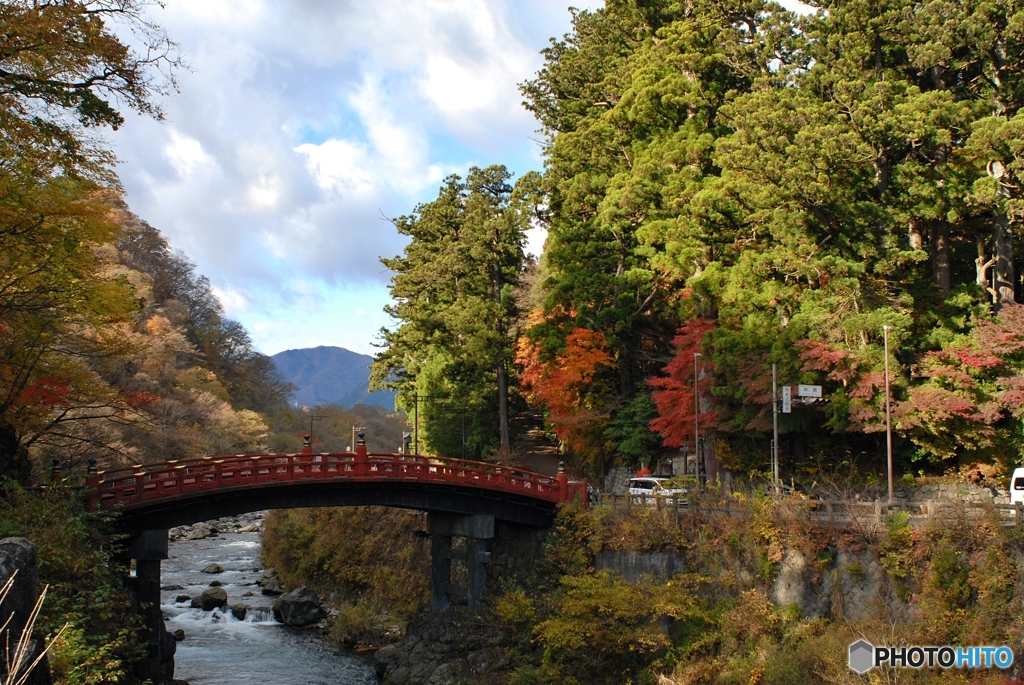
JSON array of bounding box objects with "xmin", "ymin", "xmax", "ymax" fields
[{"xmin": 88, "ymin": 448, "xmax": 587, "ymax": 507}]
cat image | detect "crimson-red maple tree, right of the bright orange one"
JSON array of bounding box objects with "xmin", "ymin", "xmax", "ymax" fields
[{"xmin": 647, "ymin": 318, "xmax": 716, "ymax": 447}]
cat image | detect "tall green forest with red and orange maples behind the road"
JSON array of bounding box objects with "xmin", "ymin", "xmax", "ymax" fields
[{"xmin": 375, "ymin": 0, "xmax": 1024, "ymax": 482}]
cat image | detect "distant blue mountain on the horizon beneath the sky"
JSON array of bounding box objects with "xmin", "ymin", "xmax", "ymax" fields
[{"xmin": 270, "ymin": 346, "xmax": 395, "ymax": 410}]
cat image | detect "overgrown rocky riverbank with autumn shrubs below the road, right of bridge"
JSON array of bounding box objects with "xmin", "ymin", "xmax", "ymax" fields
[{"xmin": 366, "ymin": 493, "xmax": 1024, "ymax": 685}]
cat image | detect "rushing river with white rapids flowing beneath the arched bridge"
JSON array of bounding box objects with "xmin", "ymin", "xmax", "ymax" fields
[{"xmin": 155, "ymin": 532, "xmax": 379, "ymax": 685}]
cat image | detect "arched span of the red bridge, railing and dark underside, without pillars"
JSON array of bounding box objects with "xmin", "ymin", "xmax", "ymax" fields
[{"xmin": 87, "ymin": 444, "xmax": 587, "ymax": 534}]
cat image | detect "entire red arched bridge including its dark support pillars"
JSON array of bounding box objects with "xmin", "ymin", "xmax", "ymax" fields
[{"xmin": 83, "ymin": 435, "xmax": 587, "ymax": 680}]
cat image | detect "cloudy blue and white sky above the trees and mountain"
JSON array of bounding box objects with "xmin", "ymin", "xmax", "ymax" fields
[{"xmin": 111, "ymin": 0, "xmax": 603, "ymax": 354}]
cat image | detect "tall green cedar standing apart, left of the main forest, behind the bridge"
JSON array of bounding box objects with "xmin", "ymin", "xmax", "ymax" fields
[{"xmin": 372, "ymin": 166, "xmax": 536, "ymax": 457}]
